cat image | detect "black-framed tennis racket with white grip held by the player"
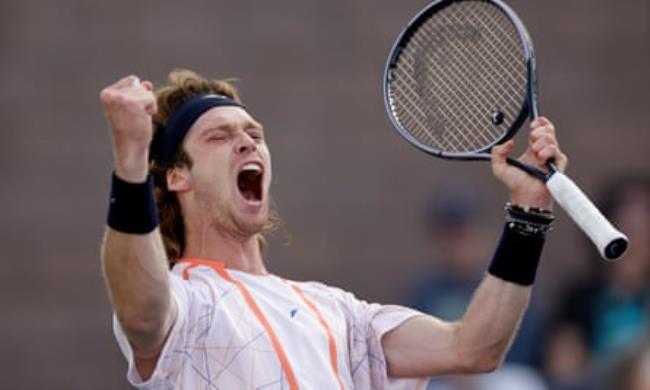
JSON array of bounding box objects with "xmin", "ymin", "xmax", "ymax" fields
[{"xmin": 384, "ymin": 0, "xmax": 627, "ymax": 260}]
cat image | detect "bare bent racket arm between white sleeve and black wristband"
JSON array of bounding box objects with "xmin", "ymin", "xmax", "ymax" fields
[{"xmin": 382, "ymin": 274, "xmax": 531, "ymax": 376}]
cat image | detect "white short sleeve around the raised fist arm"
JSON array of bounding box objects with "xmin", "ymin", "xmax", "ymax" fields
[{"xmin": 113, "ymin": 274, "xmax": 193, "ymax": 389}]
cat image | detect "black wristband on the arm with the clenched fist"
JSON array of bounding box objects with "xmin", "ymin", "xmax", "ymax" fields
[{"xmin": 107, "ymin": 174, "xmax": 158, "ymax": 234}]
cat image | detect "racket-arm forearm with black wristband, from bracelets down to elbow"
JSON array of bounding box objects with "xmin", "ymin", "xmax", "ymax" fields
[{"xmin": 457, "ymin": 205, "xmax": 553, "ymax": 372}]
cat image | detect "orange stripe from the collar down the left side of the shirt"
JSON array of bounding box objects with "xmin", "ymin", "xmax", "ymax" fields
[{"xmin": 179, "ymin": 258, "xmax": 298, "ymax": 390}]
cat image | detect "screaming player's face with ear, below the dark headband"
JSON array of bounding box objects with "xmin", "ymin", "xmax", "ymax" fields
[{"xmin": 168, "ymin": 106, "xmax": 271, "ymax": 239}]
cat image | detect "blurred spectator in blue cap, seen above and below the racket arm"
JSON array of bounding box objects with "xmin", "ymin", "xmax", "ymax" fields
[{"xmin": 406, "ymin": 182, "xmax": 542, "ymax": 390}]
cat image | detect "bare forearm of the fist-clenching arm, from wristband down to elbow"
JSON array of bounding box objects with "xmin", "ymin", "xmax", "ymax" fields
[{"xmin": 102, "ymin": 227, "xmax": 175, "ymax": 354}]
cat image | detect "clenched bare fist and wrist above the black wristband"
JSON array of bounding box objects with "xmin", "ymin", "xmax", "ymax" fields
[{"xmin": 99, "ymin": 76, "xmax": 158, "ymax": 183}]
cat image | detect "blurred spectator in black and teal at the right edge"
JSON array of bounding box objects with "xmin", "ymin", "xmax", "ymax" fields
[{"xmin": 544, "ymin": 176, "xmax": 650, "ymax": 390}]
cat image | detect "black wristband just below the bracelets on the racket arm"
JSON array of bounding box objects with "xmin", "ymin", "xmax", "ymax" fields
[{"xmin": 488, "ymin": 223, "xmax": 545, "ymax": 286}]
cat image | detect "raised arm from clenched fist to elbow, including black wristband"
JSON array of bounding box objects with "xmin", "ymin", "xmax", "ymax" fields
[{"xmin": 100, "ymin": 76, "xmax": 176, "ymax": 355}]
